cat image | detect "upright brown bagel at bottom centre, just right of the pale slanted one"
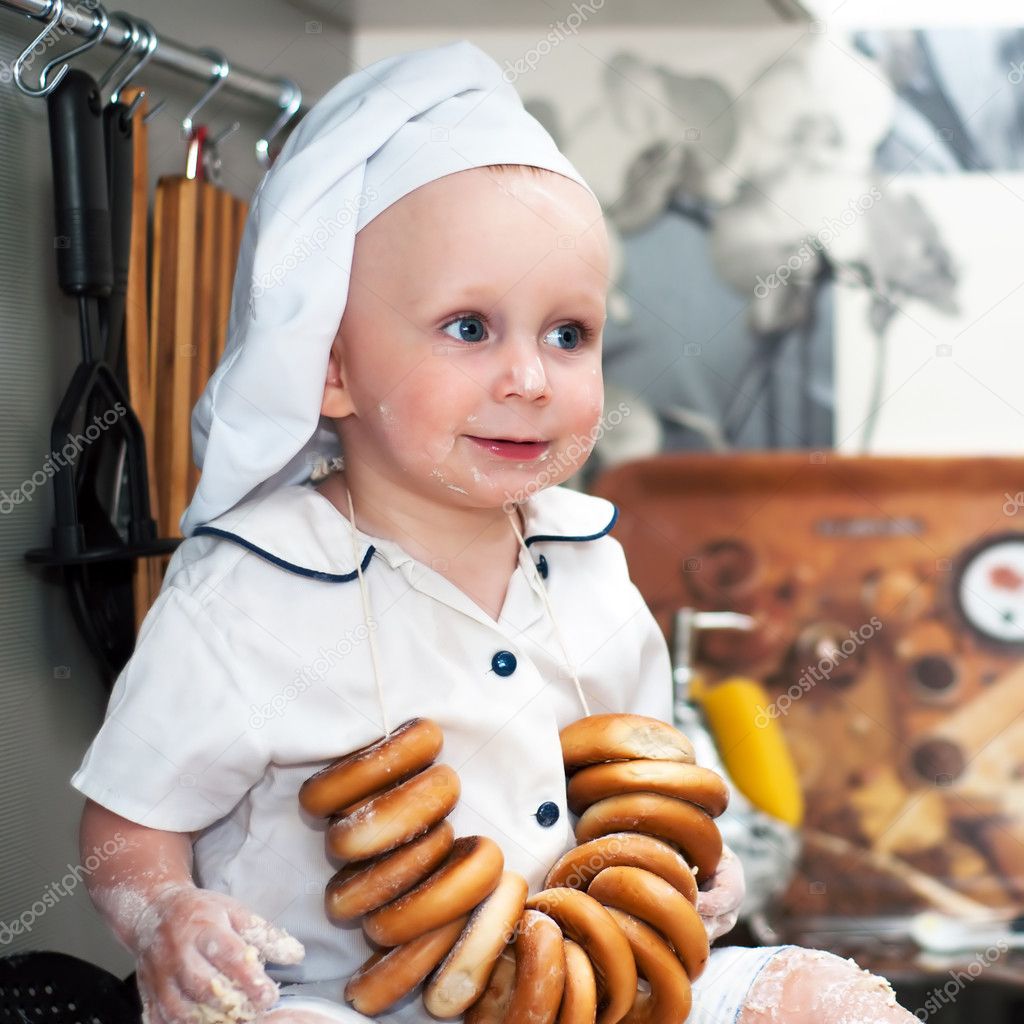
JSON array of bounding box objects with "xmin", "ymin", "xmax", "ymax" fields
[{"xmin": 503, "ymin": 910, "xmax": 565, "ymax": 1024}]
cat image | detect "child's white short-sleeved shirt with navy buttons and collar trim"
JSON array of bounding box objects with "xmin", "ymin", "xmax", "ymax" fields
[{"xmin": 72, "ymin": 484, "xmax": 672, "ymax": 1007}]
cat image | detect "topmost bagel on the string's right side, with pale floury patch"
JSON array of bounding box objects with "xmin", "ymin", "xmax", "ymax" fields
[{"xmin": 558, "ymin": 714, "xmax": 694, "ymax": 772}]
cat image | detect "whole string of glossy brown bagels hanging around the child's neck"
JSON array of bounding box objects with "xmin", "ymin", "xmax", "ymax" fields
[{"xmin": 299, "ymin": 714, "xmax": 728, "ymax": 1024}]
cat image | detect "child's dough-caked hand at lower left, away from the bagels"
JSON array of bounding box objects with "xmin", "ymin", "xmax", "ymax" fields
[{"xmin": 131, "ymin": 885, "xmax": 305, "ymax": 1024}]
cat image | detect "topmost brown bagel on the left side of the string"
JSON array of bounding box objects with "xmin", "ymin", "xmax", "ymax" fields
[{"xmin": 299, "ymin": 718, "xmax": 444, "ymax": 818}]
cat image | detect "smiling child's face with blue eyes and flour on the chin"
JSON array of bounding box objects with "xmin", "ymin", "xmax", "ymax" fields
[{"xmin": 323, "ymin": 168, "xmax": 608, "ymax": 507}]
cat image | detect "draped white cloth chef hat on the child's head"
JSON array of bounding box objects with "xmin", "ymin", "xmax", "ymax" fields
[{"xmin": 179, "ymin": 40, "xmax": 593, "ymax": 537}]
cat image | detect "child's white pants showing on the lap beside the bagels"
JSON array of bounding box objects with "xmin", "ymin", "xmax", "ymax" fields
[{"xmin": 272, "ymin": 946, "xmax": 792, "ymax": 1024}]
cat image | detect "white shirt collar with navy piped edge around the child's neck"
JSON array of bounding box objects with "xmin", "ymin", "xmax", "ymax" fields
[{"xmin": 194, "ymin": 483, "xmax": 618, "ymax": 583}]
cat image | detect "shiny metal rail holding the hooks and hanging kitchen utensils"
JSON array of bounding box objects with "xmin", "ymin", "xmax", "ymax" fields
[{"xmin": 0, "ymin": 0, "xmax": 308, "ymax": 116}]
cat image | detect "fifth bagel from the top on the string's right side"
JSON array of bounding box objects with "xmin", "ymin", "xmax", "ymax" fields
[{"xmin": 587, "ymin": 866, "xmax": 711, "ymax": 981}]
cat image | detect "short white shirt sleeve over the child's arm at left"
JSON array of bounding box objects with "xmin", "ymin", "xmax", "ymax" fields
[{"xmin": 71, "ymin": 586, "xmax": 268, "ymax": 831}]
